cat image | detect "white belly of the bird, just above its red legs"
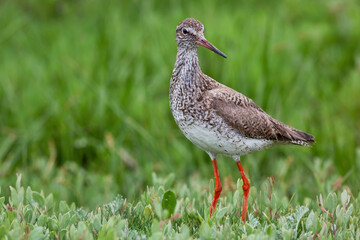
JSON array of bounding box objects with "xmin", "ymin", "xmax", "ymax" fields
[{"xmin": 180, "ymin": 124, "xmax": 274, "ymax": 157}]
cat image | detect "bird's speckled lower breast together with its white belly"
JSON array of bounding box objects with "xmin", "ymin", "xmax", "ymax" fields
[{"xmin": 171, "ymin": 96, "xmax": 273, "ymax": 157}]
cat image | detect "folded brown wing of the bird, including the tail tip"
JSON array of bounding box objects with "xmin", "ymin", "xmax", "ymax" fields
[{"xmin": 208, "ymin": 87, "xmax": 314, "ymax": 146}]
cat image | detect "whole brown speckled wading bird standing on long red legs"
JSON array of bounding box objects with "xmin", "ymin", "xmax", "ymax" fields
[{"xmin": 169, "ymin": 18, "xmax": 315, "ymax": 223}]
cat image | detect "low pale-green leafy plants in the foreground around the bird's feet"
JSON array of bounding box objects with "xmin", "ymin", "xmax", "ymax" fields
[{"xmin": 0, "ymin": 174, "xmax": 360, "ymax": 239}]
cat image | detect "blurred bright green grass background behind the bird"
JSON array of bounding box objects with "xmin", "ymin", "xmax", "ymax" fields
[{"xmin": 0, "ymin": 0, "xmax": 360, "ymax": 208}]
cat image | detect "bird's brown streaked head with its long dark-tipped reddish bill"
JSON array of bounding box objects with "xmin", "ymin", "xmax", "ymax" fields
[{"xmin": 176, "ymin": 18, "xmax": 227, "ymax": 58}]
